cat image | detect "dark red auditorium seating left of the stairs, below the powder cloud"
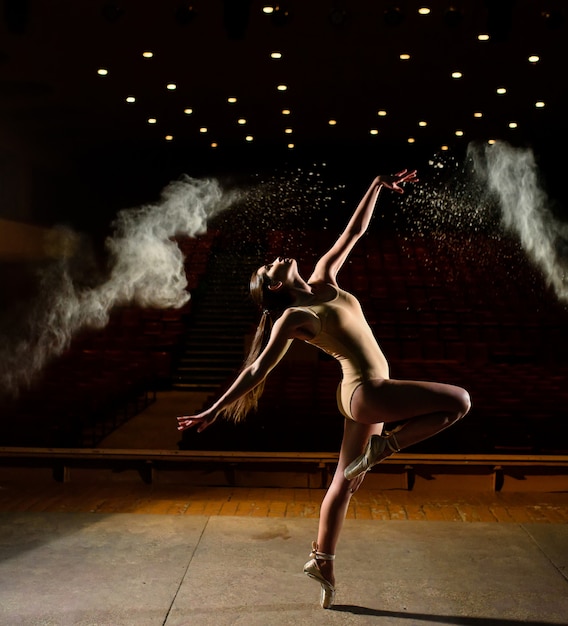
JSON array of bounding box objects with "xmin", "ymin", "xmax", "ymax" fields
[{"xmin": 0, "ymin": 233, "xmax": 215, "ymax": 447}]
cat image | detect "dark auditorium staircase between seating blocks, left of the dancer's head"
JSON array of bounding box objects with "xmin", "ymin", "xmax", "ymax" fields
[{"xmin": 172, "ymin": 249, "xmax": 258, "ymax": 392}]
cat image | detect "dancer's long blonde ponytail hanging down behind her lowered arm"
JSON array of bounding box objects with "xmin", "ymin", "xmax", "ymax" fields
[{"xmin": 219, "ymin": 270, "xmax": 290, "ymax": 423}]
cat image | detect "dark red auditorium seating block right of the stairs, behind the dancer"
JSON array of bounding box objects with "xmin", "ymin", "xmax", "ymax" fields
[{"xmin": 250, "ymin": 227, "xmax": 568, "ymax": 454}]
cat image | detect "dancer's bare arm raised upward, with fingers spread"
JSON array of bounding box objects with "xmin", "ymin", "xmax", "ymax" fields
[{"xmin": 308, "ymin": 170, "xmax": 418, "ymax": 284}]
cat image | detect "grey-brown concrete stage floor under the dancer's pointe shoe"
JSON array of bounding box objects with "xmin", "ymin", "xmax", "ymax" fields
[{"xmin": 0, "ymin": 512, "xmax": 568, "ymax": 626}]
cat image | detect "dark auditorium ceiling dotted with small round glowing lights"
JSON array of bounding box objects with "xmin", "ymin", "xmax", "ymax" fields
[{"xmin": 0, "ymin": 0, "xmax": 568, "ymax": 195}]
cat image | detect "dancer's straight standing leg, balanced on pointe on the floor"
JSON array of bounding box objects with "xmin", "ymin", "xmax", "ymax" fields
[{"xmin": 317, "ymin": 419, "xmax": 383, "ymax": 585}]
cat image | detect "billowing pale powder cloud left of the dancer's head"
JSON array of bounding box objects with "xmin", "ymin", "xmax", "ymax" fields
[{"xmin": 0, "ymin": 177, "xmax": 237, "ymax": 395}]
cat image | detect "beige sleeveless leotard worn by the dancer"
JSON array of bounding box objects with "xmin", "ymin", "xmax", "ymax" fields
[{"xmin": 301, "ymin": 287, "xmax": 389, "ymax": 419}]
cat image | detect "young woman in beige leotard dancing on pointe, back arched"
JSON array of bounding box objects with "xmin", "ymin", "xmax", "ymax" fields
[{"xmin": 178, "ymin": 170, "xmax": 470, "ymax": 608}]
